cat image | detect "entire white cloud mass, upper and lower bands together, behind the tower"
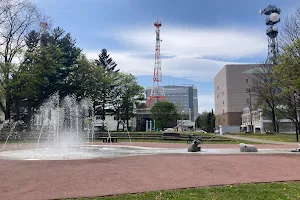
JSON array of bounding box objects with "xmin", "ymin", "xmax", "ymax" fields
[{"xmin": 87, "ymin": 27, "xmax": 267, "ymax": 82}]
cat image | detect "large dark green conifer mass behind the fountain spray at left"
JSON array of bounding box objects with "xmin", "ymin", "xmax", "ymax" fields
[{"xmin": 2, "ymin": 28, "xmax": 85, "ymax": 125}]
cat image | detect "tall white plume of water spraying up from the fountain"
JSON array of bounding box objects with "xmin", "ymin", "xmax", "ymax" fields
[{"xmin": 34, "ymin": 94, "xmax": 93, "ymax": 148}]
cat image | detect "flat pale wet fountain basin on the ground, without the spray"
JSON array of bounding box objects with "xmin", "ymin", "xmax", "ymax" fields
[{"xmin": 0, "ymin": 145, "xmax": 300, "ymax": 160}]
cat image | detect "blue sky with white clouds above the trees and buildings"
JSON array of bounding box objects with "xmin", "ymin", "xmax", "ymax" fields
[{"xmin": 35, "ymin": 0, "xmax": 300, "ymax": 112}]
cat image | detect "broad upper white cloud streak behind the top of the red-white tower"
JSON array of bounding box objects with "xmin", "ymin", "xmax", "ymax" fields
[{"xmin": 115, "ymin": 26, "xmax": 267, "ymax": 59}]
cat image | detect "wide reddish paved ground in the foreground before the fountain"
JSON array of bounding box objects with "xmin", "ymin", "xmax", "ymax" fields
[{"xmin": 0, "ymin": 154, "xmax": 300, "ymax": 200}]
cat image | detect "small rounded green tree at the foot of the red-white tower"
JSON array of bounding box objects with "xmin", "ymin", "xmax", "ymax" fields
[{"xmin": 150, "ymin": 102, "xmax": 177, "ymax": 129}]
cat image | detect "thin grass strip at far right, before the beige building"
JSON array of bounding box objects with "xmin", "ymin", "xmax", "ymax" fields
[{"xmin": 231, "ymin": 133, "xmax": 296, "ymax": 142}]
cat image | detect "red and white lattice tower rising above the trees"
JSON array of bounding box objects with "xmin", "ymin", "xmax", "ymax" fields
[{"xmin": 147, "ymin": 20, "xmax": 167, "ymax": 107}]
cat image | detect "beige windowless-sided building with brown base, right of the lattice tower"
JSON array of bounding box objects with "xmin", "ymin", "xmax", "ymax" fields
[{"xmin": 214, "ymin": 64, "xmax": 259, "ymax": 129}]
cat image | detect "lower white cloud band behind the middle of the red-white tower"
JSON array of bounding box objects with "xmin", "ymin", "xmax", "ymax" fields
[{"xmin": 86, "ymin": 51, "xmax": 241, "ymax": 82}]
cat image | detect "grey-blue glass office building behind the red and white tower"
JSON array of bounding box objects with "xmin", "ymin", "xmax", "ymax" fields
[{"xmin": 146, "ymin": 85, "xmax": 198, "ymax": 121}]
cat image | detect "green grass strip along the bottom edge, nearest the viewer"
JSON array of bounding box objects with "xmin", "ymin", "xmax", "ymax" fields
[{"xmin": 68, "ymin": 182, "xmax": 300, "ymax": 200}]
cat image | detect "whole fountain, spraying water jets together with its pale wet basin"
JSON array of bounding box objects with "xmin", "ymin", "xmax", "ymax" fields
[{"xmin": 0, "ymin": 94, "xmax": 300, "ymax": 160}]
